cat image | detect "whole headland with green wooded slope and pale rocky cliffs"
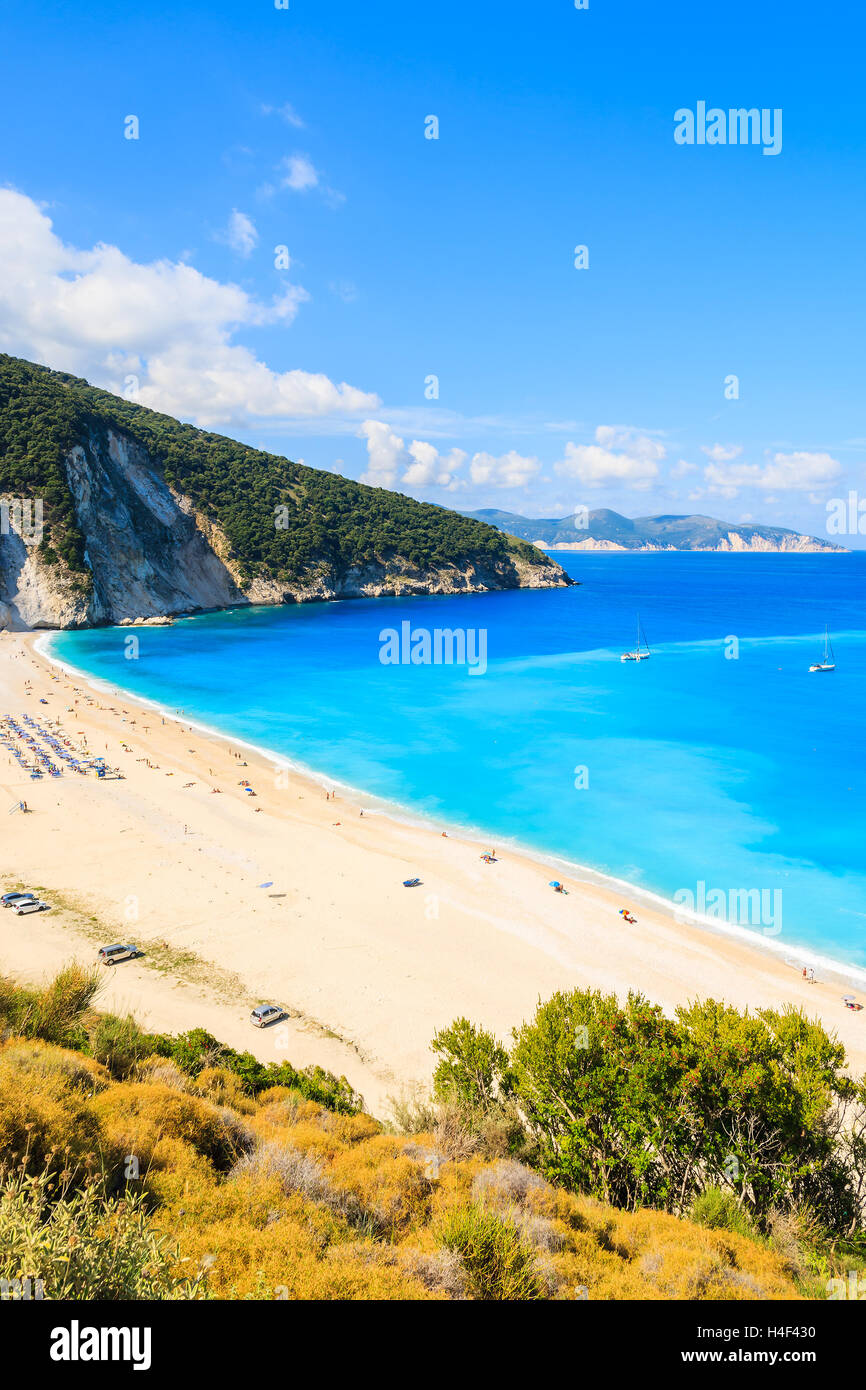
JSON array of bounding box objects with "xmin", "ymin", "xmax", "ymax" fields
[{"xmin": 0, "ymin": 354, "xmax": 570, "ymax": 627}]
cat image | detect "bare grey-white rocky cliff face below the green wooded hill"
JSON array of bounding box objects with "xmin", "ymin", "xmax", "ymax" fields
[{"xmin": 0, "ymin": 428, "xmax": 570, "ymax": 630}]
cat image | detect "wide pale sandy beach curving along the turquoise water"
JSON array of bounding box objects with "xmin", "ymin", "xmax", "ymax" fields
[{"xmin": 0, "ymin": 632, "xmax": 866, "ymax": 1115}]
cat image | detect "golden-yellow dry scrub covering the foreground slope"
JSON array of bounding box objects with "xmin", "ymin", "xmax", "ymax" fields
[{"xmin": 0, "ymin": 1040, "xmax": 798, "ymax": 1300}]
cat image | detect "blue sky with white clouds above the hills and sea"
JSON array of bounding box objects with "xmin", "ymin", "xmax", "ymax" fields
[{"xmin": 0, "ymin": 0, "xmax": 866, "ymax": 543}]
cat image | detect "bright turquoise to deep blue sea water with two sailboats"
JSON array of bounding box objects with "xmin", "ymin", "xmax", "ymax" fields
[{"xmin": 49, "ymin": 553, "xmax": 866, "ymax": 969}]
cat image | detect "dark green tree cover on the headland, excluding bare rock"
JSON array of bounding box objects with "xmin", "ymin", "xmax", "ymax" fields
[{"xmin": 0, "ymin": 354, "xmax": 556, "ymax": 581}]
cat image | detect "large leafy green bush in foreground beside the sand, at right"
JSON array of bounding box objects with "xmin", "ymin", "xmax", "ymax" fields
[{"xmin": 432, "ymin": 990, "xmax": 866, "ymax": 1238}]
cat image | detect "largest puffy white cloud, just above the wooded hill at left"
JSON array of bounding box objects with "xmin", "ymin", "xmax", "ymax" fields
[{"xmin": 0, "ymin": 189, "xmax": 379, "ymax": 427}]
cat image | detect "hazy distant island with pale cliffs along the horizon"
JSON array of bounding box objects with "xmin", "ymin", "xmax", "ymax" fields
[{"xmin": 464, "ymin": 507, "xmax": 845, "ymax": 552}]
